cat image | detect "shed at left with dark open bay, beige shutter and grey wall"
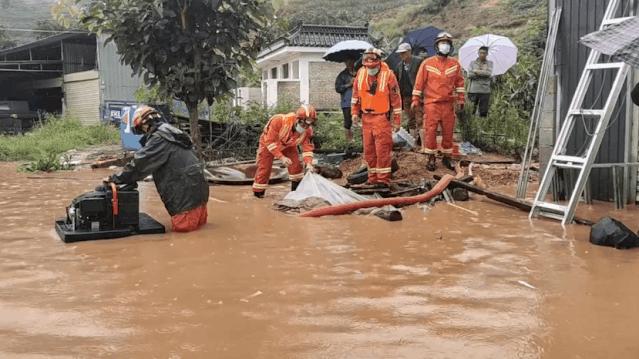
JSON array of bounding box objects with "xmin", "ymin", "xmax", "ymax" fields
[{"xmin": 0, "ymin": 32, "xmax": 143, "ymax": 124}]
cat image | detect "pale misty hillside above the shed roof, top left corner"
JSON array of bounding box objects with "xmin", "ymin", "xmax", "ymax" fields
[{"xmin": 0, "ymin": 0, "xmax": 55, "ymax": 44}]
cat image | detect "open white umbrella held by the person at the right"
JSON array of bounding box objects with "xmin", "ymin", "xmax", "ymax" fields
[{"xmin": 459, "ymin": 34, "xmax": 517, "ymax": 76}]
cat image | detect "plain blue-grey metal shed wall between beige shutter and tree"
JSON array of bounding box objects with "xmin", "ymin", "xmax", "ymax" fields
[{"xmin": 98, "ymin": 36, "xmax": 144, "ymax": 104}]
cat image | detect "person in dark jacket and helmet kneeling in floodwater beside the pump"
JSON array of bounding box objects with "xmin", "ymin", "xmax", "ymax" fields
[{"xmin": 106, "ymin": 106, "xmax": 209, "ymax": 232}]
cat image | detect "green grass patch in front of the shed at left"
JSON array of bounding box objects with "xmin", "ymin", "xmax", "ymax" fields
[{"xmin": 0, "ymin": 117, "xmax": 120, "ymax": 171}]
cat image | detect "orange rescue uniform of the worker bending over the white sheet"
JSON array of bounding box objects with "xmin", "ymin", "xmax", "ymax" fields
[{"xmin": 253, "ymin": 113, "xmax": 314, "ymax": 193}]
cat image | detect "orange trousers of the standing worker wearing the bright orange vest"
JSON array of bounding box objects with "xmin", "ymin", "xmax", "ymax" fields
[{"xmin": 362, "ymin": 113, "xmax": 393, "ymax": 184}]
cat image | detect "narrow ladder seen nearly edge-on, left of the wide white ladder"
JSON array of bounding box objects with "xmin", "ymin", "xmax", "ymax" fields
[{"xmin": 517, "ymin": 8, "xmax": 562, "ymax": 199}]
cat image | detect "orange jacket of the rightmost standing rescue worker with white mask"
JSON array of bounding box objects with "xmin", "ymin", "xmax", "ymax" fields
[{"xmin": 413, "ymin": 56, "xmax": 466, "ymax": 104}]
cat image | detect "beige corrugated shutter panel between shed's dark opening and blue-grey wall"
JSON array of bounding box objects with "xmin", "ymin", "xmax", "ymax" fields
[{"xmin": 64, "ymin": 71, "xmax": 100, "ymax": 125}]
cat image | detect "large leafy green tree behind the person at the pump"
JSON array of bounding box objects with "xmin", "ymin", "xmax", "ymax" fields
[{"xmin": 82, "ymin": 0, "xmax": 272, "ymax": 154}]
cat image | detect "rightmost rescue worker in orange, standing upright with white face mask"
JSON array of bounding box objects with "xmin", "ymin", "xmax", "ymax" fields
[{"xmin": 411, "ymin": 32, "xmax": 465, "ymax": 171}]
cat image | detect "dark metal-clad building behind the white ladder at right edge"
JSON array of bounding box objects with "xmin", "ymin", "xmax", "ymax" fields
[{"xmin": 539, "ymin": 0, "xmax": 639, "ymax": 202}]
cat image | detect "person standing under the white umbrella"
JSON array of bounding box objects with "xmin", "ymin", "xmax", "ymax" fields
[{"xmin": 468, "ymin": 46, "xmax": 493, "ymax": 117}]
